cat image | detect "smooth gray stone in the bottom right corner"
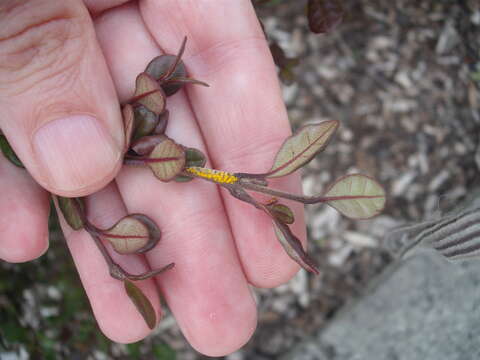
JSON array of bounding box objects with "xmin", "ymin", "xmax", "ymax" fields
[{"xmin": 282, "ymin": 252, "xmax": 480, "ymax": 360}]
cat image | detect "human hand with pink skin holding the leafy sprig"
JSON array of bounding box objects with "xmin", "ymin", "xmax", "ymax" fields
[{"xmin": 0, "ymin": 0, "xmax": 305, "ymax": 356}]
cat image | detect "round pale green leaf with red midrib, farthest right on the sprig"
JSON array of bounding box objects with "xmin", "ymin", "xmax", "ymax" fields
[{"xmin": 324, "ymin": 174, "xmax": 386, "ymax": 219}]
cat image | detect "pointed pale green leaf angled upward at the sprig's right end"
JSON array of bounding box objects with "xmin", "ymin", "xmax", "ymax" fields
[{"xmin": 266, "ymin": 120, "xmax": 339, "ymax": 178}]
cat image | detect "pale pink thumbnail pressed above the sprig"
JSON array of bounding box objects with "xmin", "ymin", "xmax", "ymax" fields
[{"xmin": 33, "ymin": 115, "xmax": 121, "ymax": 192}]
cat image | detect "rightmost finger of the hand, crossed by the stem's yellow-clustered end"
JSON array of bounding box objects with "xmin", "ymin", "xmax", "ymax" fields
[{"xmin": 140, "ymin": 0, "xmax": 305, "ymax": 287}]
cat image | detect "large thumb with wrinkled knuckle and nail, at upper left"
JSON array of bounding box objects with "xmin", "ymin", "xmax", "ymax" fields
[{"xmin": 0, "ymin": 0, "xmax": 124, "ymax": 196}]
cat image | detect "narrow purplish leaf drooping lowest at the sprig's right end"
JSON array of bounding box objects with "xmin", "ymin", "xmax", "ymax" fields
[{"xmin": 273, "ymin": 219, "xmax": 320, "ymax": 275}]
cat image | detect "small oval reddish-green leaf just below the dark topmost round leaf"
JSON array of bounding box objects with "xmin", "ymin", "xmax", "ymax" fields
[{"xmin": 133, "ymin": 73, "xmax": 166, "ymax": 115}]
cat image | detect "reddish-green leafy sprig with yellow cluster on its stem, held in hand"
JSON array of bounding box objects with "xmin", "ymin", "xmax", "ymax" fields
[{"xmin": 0, "ymin": 38, "xmax": 385, "ymax": 328}]
